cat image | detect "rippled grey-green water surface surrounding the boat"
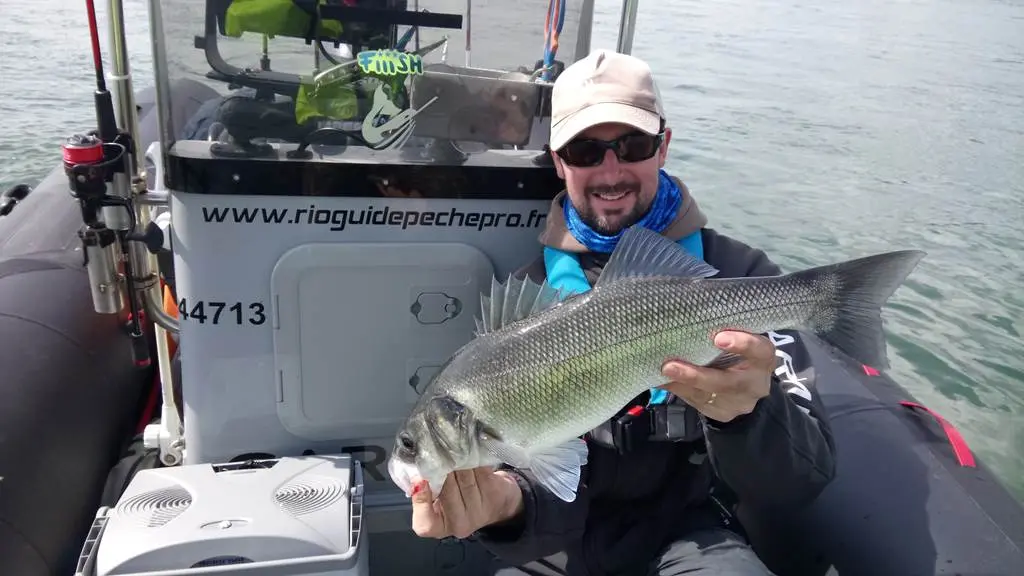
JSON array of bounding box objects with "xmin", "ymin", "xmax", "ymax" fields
[{"xmin": 0, "ymin": 0, "xmax": 1024, "ymax": 497}]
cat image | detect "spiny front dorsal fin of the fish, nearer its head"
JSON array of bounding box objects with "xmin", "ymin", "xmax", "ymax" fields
[{"xmin": 476, "ymin": 276, "xmax": 569, "ymax": 336}]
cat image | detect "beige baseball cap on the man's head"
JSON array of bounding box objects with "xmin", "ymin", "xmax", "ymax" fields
[{"xmin": 549, "ymin": 49, "xmax": 665, "ymax": 150}]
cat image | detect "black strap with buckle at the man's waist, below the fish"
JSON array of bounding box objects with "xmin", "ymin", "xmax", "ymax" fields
[{"xmin": 590, "ymin": 404, "xmax": 703, "ymax": 454}]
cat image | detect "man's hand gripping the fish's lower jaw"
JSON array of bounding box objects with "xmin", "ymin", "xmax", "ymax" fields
[{"xmin": 413, "ymin": 467, "xmax": 522, "ymax": 539}]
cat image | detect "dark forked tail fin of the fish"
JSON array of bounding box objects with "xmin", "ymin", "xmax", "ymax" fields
[{"xmin": 793, "ymin": 250, "xmax": 925, "ymax": 370}]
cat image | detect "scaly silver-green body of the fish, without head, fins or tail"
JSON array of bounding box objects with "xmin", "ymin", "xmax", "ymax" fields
[{"xmin": 439, "ymin": 270, "xmax": 815, "ymax": 447}]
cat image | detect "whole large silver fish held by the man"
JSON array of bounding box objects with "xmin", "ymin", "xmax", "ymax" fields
[{"xmin": 388, "ymin": 227, "xmax": 925, "ymax": 501}]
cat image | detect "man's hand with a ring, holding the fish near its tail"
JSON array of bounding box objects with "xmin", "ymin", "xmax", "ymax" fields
[{"xmin": 662, "ymin": 331, "xmax": 775, "ymax": 422}]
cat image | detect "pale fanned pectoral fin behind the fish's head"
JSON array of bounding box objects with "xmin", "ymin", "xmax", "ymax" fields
[{"xmin": 481, "ymin": 435, "xmax": 588, "ymax": 502}]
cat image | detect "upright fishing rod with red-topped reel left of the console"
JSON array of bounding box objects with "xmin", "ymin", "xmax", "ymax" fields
[{"xmin": 61, "ymin": 0, "xmax": 168, "ymax": 368}]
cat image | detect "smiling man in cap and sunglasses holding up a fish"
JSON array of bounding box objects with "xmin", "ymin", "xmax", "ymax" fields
[{"xmin": 405, "ymin": 51, "xmax": 835, "ymax": 576}]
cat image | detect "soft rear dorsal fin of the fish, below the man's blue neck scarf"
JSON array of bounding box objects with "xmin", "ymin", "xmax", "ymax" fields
[{"xmin": 594, "ymin": 225, "xmax": 718, "ymax": 288}]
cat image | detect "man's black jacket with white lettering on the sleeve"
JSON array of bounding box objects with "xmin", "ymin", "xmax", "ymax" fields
[{"xmin": 476, "ymin": 229, "xmax": 835, "ymax": 576}]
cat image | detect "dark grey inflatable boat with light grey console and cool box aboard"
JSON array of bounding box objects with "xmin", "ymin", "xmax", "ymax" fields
[{"xmin": 0, "ymin": 0, "xmax": 1024, "ymax": 576}]
